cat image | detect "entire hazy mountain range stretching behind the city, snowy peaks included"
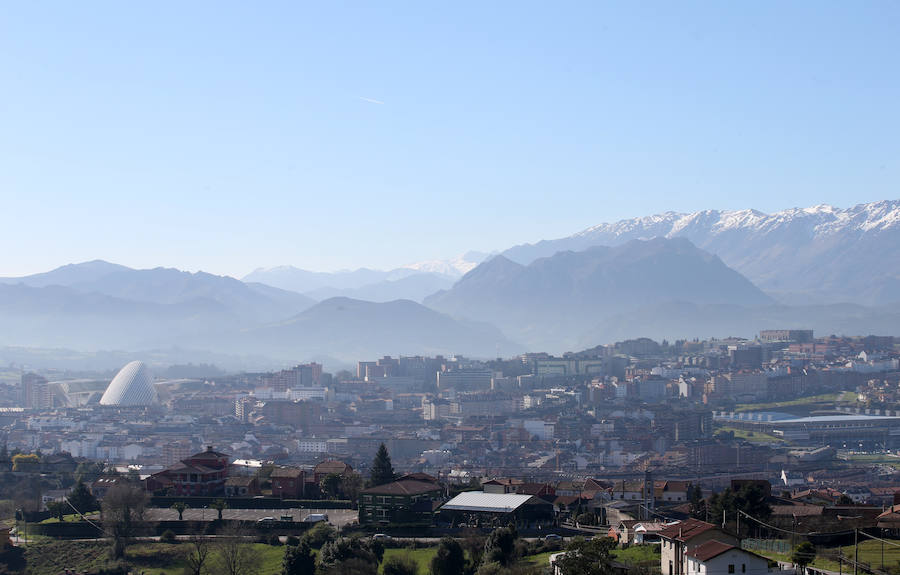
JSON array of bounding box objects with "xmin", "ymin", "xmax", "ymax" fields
[{"xmin": 0, "ymin": 200, "xmax": 900, "ymax": 362}]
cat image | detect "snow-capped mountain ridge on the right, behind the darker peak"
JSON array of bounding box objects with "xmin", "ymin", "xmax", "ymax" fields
[{"xmin": 503, "ymin": 200, "xmax": 900, "ymax": 305}]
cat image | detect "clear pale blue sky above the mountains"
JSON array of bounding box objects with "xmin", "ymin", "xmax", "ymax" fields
[{"xmin": 0, "ymin": 0, "xmax": 900, "ymax": 276}]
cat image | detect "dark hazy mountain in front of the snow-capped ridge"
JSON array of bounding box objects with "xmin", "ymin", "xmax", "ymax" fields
[{"xmin": 425, "ymin": 238, "xmax": 773, "ymax": 351}]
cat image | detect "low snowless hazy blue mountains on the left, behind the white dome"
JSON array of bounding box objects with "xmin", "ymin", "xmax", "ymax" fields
[{"xmin": 0, "ymin": 261, "xmax": 522, "ymax": 363}]
